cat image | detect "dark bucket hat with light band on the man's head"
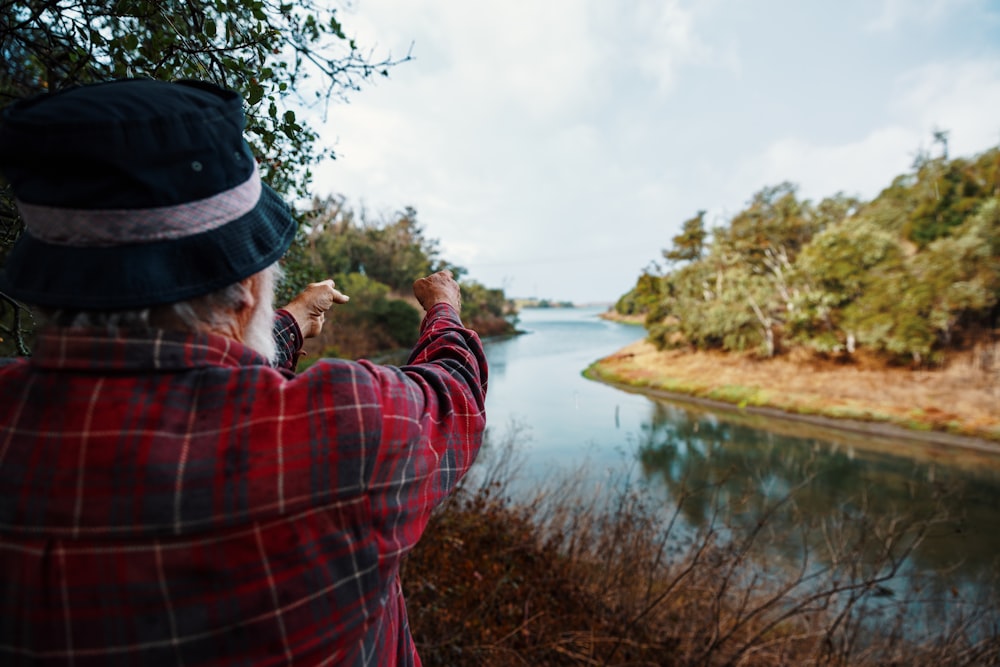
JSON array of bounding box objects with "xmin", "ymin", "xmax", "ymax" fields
[{"xmin": 0, "ymin": 79, "xmax": 296, "ymax": 310}]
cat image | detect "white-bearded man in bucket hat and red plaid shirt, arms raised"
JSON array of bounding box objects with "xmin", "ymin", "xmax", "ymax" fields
[{"xmin": 0, "ymin": 80, "xmax": 487, "ymax": 666}]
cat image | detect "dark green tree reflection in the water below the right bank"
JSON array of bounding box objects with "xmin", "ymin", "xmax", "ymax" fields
[{"xmin": 638, "ymin": 402, "xmax": 1000, "ymax": 591}]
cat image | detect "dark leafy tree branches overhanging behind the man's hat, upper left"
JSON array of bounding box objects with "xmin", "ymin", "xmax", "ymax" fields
[{"xmin": 0, "ymin": 0, "xmax": 409, "ymax": 354}]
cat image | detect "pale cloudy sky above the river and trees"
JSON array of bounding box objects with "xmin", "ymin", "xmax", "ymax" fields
[{"xmin": 314, "ymin": 0, "xmax": 1000, "ymax": 303}]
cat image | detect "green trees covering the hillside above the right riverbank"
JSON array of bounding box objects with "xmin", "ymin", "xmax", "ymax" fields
[{"xmin": 615, "ymin": 140, "xmax": 1000, "ymax": 365}]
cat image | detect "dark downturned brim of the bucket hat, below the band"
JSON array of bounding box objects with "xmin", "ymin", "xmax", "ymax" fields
[{"xmin": 0, "ymin": 185, "xmax": 296, "ymax": 310}]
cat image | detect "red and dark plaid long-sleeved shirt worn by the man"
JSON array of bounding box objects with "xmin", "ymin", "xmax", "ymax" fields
[{"xmin": 0, "ymin": 304, "xmax": 486, "ymax": 666}]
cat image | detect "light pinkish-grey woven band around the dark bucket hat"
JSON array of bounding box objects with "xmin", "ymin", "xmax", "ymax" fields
[{"xmin": 17, "ymin": 166, "xmax": 261, "ymax": 248}]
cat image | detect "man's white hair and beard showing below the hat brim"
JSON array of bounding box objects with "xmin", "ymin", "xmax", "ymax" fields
[{"xmin": 41, "ymin": 263, "xmax": 284, "ymax": 363}]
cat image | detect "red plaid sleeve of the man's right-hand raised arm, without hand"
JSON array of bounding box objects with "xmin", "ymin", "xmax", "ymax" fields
[{"xmin": 362, "ymin": 303, "xmax": 488, "ymax": 558}]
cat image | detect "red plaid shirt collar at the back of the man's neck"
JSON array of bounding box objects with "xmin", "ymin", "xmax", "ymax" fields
[{"xmin": 31, "ymin": 329, "xmax": 269, "ymax": 371}]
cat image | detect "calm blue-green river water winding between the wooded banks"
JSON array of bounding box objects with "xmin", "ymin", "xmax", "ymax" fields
[{"xmin": 486, "ymin": 308, "xmax": 1000, "ymax": 604}]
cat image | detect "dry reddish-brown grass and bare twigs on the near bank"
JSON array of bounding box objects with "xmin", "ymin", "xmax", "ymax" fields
[{"xmin": 403, "ymin": 436, "xmax": 1000, "ymax": 667}]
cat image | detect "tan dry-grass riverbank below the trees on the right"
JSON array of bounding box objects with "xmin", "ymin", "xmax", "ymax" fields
[{"xmin": 584, "ymin": 341, "xmax": 1000, "ymax": 453}]
